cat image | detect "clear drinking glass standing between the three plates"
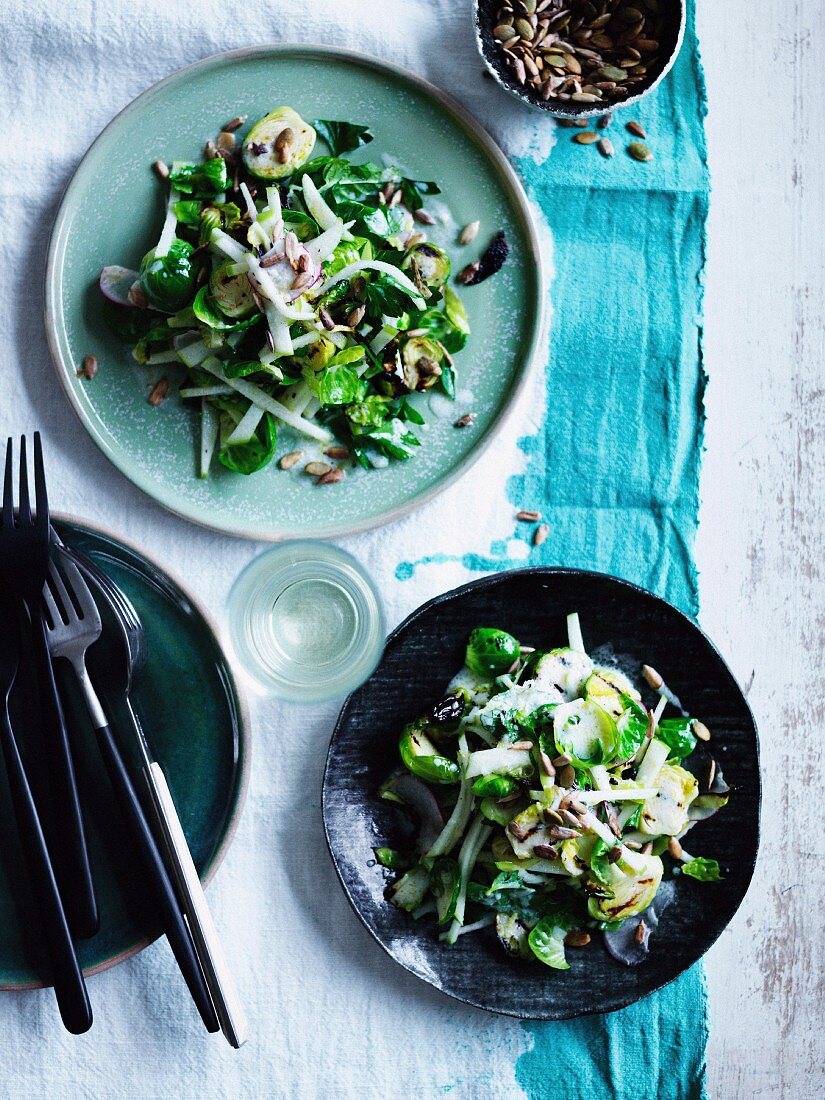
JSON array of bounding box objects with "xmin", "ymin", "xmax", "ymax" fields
[{"xmin": 229, "ymin": 541, "xmax": 385, "ymax": 703}]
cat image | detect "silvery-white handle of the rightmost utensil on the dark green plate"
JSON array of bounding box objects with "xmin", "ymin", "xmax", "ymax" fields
[{"xmin": 144, "ymin": 761, "xmax": 248, "ymax": 1049}]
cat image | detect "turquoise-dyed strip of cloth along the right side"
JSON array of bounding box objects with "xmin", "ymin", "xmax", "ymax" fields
[{"xmin": 397, "ymin": 4, "xmax": 710, "ymax": 1100}]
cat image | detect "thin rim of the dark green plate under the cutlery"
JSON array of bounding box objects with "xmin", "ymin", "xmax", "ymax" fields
[{"xmin": 0, "ymin": 512, "xmax": 252, "ymax": 992}]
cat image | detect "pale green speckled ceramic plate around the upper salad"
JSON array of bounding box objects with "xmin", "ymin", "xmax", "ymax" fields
[{"xmin": 46, "ymin": 46, "xmax": 545, "ymax": 539}]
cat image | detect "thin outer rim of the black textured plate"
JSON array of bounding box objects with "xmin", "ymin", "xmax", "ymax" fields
[{"xmin": 321, "ymin": 565, "xmax": 762, "ymax": 1022}]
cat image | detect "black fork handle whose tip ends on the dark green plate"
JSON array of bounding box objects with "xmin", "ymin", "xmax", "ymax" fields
[{"xmin": 31, "ymin": 609, "xmax": 100, "ymax": 939}]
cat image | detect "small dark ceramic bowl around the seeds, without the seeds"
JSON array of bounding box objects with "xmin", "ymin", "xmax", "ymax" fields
[{"xmin": 473, "ymin": 0, "xmax": 686, "ymax": 119}]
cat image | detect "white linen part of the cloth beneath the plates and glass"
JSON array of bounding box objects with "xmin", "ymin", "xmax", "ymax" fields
[{"xmin": 0, "ymin": 0, "xmax": 553, "ymax": 1100}]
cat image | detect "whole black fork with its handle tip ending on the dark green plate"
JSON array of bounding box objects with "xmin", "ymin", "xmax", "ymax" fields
[{"xmin": 0, "ymin": 431, "xmax": 100, "ymax": 939}]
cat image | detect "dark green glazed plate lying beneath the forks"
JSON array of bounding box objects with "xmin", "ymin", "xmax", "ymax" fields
[{"xmin": 0, "ymin": 521, "xmax": 249, "ymax": 989}]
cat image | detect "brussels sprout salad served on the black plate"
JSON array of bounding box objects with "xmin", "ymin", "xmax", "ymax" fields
[{"xmin": 375, "ymin": 614, "xmax": 728, "ymax": 970}]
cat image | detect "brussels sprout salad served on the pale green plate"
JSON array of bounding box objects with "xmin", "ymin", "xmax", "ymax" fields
[{"xmin": 99, "ymin": 107, "xmax": 479, "ymax": 483}]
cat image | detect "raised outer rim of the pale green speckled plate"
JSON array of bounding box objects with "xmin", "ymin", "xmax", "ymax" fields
[{"xmin": 45, "ymin": 42, "xmax": 547, "ymax": 542}]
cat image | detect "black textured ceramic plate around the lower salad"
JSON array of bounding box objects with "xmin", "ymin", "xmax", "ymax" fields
[{"xmin": 323, "ymin": 569, "xmax": 760, "ymax": 1020}]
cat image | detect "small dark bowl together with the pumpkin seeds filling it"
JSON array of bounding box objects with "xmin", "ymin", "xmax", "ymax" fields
[{"xmin": 475, "ymin": 0, "xmax": 686, "ymax": 119}]
